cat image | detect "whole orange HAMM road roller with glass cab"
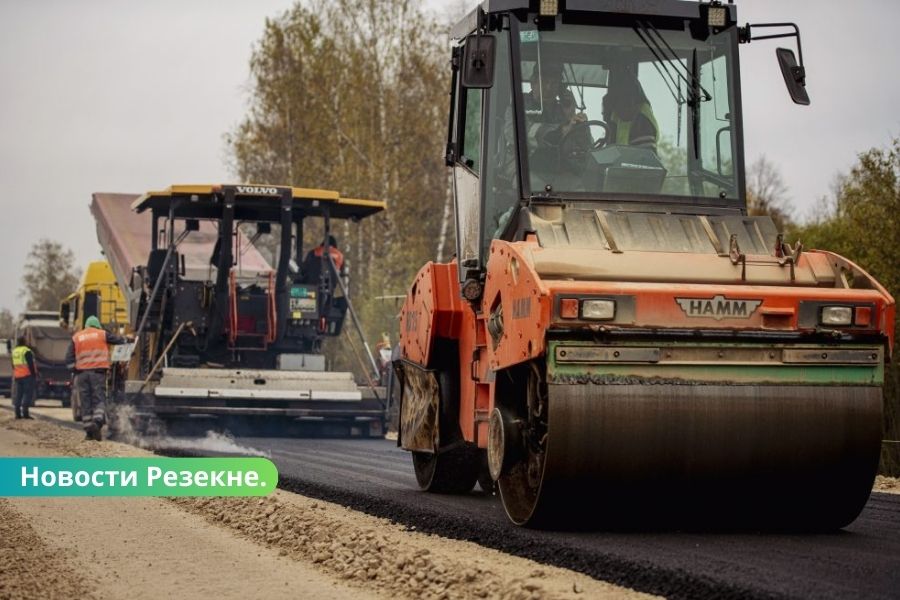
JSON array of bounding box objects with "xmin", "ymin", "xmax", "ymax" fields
[{"xmin": 395, "ymin": 0, "xmax": 895, "ymax": 529}]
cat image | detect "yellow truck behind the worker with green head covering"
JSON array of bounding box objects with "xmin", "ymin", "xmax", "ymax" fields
[{"xmin": 59, "ymin": 260, "xmax": 132, "ymax": 422}]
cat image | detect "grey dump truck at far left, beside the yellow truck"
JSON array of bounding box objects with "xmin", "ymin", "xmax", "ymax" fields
[{"xmin": 14, "ymin": 310, "xmax": 72, "ymax": 407}]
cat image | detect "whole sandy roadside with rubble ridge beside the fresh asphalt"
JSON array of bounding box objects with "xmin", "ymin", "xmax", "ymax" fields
[{"xmin": 0, "ymin": 410, "xmax": 644, "ymax": 599}]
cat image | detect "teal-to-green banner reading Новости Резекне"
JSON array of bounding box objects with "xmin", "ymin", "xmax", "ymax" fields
[{"xmin": 0, "ymin": 457, "xmax": 278, "ymax": 497}]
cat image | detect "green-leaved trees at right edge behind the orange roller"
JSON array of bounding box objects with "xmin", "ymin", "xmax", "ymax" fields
[{"xmin": 792, "ymin": 138, "xmax": 900, "ymax": 475}]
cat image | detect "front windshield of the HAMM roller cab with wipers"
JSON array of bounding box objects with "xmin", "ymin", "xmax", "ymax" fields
[{"xmin": 519, "ymin": 20, "xmax": 739, "ymax": 199}]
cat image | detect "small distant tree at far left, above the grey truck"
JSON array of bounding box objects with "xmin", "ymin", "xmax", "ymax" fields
[{"xmin": 19, "ymin": 238, "xmax": 81, "ymax": 310}]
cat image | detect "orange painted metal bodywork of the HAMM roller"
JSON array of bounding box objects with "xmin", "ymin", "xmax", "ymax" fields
[{"xmin": 400, "ymin": 236, "xmax": 895, "ymax": 448}]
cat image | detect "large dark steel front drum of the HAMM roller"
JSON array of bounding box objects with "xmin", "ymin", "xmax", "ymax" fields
[{"xmin": 498, "ymin": 382, "xmax": 882, "ymax": 530}]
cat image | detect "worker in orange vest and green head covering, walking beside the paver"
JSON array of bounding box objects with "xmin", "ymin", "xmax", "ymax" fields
[{"xmin": 66, "ymin": 316, "xmax": 128, "ymax": 442}]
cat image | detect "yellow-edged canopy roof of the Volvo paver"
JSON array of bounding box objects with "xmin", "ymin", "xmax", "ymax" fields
[{"xmin": 131, "ymin": 184, "xmax": 387, "ymax": 222}]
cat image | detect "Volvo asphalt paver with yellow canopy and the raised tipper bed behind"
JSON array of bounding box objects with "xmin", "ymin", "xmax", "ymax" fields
[{"xmin": 91, "ymin": 185, "xmax": 385, "ymax": 435}]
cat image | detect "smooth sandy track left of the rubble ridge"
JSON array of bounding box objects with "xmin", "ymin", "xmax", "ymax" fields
[{"xmin": 0, "ymin": 422, "xmax": 383, "ymax": 600}]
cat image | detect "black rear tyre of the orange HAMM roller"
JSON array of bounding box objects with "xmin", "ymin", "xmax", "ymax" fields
[{"xmin": 412, "ymin": 341, "xmax": 481, "ymax": 494}]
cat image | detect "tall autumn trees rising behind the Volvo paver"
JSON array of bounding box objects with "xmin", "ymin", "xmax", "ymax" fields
[{"xmin": 226, "ymin": 0, "xmax": 453, "ymax": 372}]
